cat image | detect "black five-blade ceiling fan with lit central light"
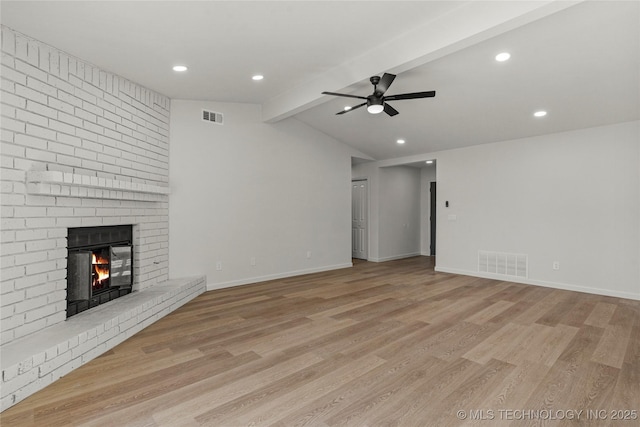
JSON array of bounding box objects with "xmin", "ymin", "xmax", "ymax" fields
[{"xmin": 322, "ymin": 73, "xmax": 436, "ymax": 117}]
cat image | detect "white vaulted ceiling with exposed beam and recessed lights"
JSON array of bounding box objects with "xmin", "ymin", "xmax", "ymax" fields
[{"xmin": 0, "ymin": 0, "xmax": 640, "ymax": 159}]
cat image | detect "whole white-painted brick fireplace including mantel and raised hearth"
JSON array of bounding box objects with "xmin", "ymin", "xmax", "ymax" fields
[{"xmin": 0, "ymin": 26, "xmax": 204, "ymax": 409}]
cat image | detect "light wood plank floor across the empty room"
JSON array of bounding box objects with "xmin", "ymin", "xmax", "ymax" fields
[{"xmin": 0, "ymin": 257, "xmax": 640, "ymax": 427}]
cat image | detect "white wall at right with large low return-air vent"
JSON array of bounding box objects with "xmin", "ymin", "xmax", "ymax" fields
[{"xmin": 436, "ymin": 122, "xmax": 640, "ymax": 299}]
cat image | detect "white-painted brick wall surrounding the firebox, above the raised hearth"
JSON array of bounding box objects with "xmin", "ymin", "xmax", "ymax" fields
[{"xmin": 0, "ymin": 26, "xmax": 170, "ymax": 346}]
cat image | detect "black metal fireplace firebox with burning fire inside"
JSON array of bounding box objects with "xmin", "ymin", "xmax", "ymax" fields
[{"xmin": 67, "ymin": 225, "xmax": 133, "ymax": 318}]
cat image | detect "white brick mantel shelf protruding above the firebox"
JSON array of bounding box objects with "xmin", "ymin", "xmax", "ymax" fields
[{"xmin": 27, "ymin": 171, "xmax": 170, "ymax": 202}]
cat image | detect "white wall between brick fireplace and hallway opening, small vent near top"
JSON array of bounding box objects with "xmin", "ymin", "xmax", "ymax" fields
[{"xmin": 169, "ymin": 100, "xmax": 352, "ymax": 289}]
